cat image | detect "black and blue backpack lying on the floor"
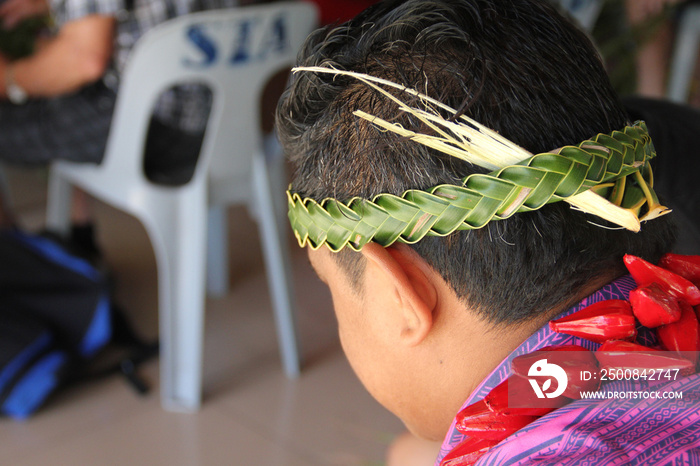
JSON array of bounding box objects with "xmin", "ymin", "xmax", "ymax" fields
[{"xmin": 0, "ymin": 229, "xmax": 157, "ymax": 419}]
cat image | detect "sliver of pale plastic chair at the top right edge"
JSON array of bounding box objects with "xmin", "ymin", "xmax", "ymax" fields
[{"xmin": 667, "ymin": 3, "xmax": 700, "ymax": 103}]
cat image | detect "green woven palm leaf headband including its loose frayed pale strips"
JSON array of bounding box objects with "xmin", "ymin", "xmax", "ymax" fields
[{"xmin": 287, "ymin": 67, "xmax": 670, "ymax": 252}]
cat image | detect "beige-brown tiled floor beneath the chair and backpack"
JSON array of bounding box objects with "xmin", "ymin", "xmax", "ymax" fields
[{"xmin": 0, "ymin": 169, "xmax": 402, "ymax": 466}]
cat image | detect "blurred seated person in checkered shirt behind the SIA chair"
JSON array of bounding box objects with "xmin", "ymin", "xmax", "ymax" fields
[{"xmin": 0, "ymin": 0, "xmax": 238, "ymax": 255}]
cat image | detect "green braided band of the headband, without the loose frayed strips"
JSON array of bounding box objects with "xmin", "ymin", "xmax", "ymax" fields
[{"xmin": 287, "ymin": 121, "xmax": 656, "ymax": 251}]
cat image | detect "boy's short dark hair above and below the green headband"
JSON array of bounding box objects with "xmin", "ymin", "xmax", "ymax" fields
[{"xmin": 277, "ymin": 0, "xmax": 673, "ymax": 323}]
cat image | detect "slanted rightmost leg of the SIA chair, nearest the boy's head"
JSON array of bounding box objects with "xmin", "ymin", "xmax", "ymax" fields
[{"xmin": 253, "ymin": 153, "xmax": 301, "ymax": 378}]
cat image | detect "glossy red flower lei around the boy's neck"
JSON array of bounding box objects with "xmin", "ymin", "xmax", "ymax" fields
[{"xmin": 440, "ymin": 253, "xmax": 700, "ymax": 466}]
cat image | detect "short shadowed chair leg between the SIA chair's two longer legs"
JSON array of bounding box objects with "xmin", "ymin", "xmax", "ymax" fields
[{"xmin": 207, "ymin": 206, "xmax": 229, "ymax": 298}]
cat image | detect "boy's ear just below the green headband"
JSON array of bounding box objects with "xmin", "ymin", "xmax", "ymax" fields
[{"xmin": 361, "ymin": 243, "xmax": 438, "ymax": 346}]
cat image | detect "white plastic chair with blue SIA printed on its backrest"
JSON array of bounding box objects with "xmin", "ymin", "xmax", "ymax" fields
[{"xmin": 47, "ymin": 2, "xmax": 317, "ymax": 411}]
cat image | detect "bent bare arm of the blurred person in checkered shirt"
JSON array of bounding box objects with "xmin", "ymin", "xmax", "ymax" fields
[{"xmin": 0, "ymin": 15, "xmax": 115, "ymax": 98}]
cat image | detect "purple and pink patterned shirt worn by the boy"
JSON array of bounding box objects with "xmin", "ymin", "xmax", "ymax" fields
[{"xmin": 435, "ymin": 276, "xmax": 700, "ymax": 466}]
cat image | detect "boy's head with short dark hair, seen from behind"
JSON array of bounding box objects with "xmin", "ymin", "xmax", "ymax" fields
[{"xmin": 277, "ymin": 0, "xmax": 673, "ymax": 437}]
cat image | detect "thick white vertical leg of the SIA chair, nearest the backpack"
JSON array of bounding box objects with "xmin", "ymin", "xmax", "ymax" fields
[{"xmin": 143, "ymin": 194, "xmax": 207, "ymax": 412}]
